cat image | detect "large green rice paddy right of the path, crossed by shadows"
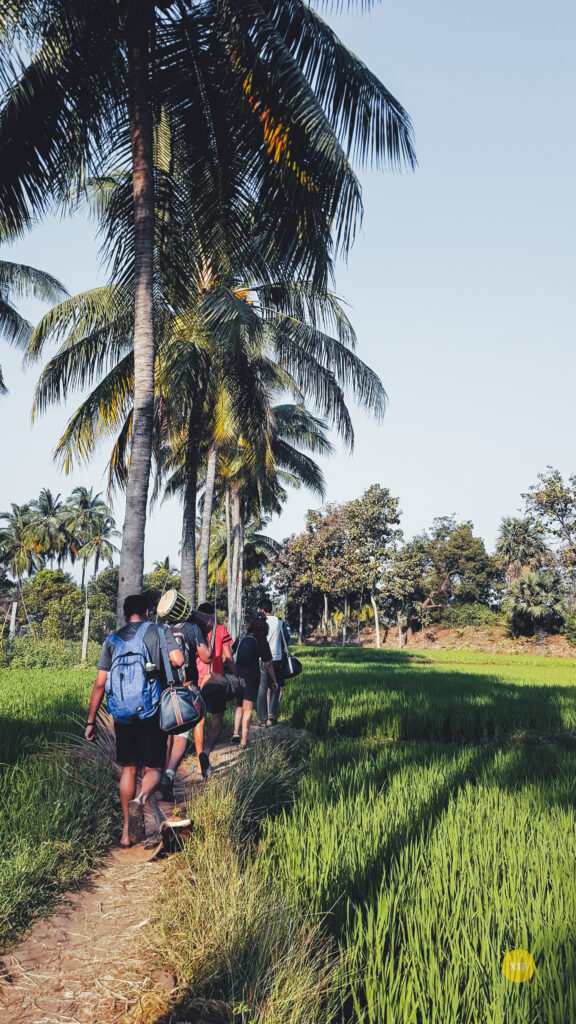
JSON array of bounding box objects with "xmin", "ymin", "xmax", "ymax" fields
[{"xmin": 261, "ymin": 649, "xmax": 576, "ymax": 1024}]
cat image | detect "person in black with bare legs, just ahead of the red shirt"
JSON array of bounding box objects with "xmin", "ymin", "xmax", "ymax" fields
[{"xmin": 232, "ymin": 612, "xmax": 278, "ymax": 748}]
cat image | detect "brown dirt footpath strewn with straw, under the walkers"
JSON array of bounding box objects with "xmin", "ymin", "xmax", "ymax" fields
[{"xmin": 0, "ymin": 746, "xmax": 238, "ymax": 1024}]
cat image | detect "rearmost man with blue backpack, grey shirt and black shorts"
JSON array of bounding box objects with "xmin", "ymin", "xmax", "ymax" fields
[{"xmin": 84, "ymin": 594, "xmax": 184, "ymax": 847}]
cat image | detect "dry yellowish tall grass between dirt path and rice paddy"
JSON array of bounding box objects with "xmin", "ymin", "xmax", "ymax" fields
[{"xmin": 143, "ymin": 740, "xmax": 335, "ymax": 1024}]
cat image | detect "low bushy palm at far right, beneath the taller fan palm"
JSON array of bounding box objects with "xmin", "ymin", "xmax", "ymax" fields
[{"xmin": 503, "ymin": 569, "xmax": 567, "ymax": 644}]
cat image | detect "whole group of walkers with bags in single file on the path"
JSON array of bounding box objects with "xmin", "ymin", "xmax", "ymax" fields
[{"xmin": 85, "ymin": 591, "xmax": 291, "ymax": 847}]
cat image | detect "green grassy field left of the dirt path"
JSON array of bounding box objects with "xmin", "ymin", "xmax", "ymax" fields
[{"xmin": 0, "ymin": 669, "xmax": 118, "ymax": 947}]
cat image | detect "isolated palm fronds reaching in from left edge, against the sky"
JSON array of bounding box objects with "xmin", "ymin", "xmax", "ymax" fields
[{"xmin": 0, "ymin": 260, "xmax": 68, "ymax": 394}]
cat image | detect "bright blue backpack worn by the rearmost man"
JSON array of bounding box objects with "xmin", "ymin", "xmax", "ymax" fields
[{"xmin": 106, "ymin": 622, "xmax": 162, "ymax": 725}]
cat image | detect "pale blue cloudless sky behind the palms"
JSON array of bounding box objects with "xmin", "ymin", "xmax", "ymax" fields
[{"xmin": 0, "ymin": 0, "xmax": 576, "ymax": 567}]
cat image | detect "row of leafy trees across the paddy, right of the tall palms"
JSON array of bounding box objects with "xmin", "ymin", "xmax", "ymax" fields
[{"xmin": 271, "ymin": 467, "xmax": 576, "ymax": 647}]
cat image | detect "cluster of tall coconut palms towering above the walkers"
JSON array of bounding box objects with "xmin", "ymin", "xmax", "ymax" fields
[{"xmin": 0, "ymin": 0, "xmax": 415, "ymax": 632}]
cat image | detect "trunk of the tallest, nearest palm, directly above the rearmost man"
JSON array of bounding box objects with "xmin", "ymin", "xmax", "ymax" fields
[{"xmin": 117, "ymin": 0, "xmax": 155, "ymax": 622}]
